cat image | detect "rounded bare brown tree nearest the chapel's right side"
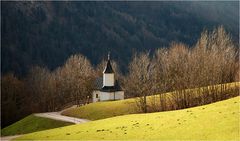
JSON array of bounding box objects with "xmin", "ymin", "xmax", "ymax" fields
[{"xmin": 124, "ymin": 53, "xmax": 153, "ymax": 113}]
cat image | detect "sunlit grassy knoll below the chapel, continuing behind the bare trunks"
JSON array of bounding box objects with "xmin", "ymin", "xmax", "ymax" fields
[{"xmin": 62, "ymin": 82, "xmax": 240, "ymax": 120}]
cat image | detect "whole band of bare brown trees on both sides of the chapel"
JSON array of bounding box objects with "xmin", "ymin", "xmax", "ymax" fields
[{"xmin": 1, "ymin": 27, "xmax": 240, "ymax": 127}]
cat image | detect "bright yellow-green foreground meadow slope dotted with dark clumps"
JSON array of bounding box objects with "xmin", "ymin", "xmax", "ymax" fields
[{"xmin": 17, "ymin": 96, "xmax": 240, "ymax": 140}]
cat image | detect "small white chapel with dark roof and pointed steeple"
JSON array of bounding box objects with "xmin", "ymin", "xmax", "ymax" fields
[{"xmin": 92, "ymin": 54, "xmax": 124, "ymax": 102}]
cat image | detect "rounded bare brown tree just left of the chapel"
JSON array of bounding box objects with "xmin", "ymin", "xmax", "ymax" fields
[{"xmin": 62, "ymin": 55, "xmax": 95, "ymax": 106}]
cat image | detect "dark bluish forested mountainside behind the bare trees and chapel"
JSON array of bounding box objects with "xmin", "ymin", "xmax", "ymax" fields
[{"xmin": 1, "ymin": 2, "xmax": 239, "ymax": 76}]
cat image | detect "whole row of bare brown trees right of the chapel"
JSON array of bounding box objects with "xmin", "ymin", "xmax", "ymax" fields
[{"xmin": 125, "ymin": 27, "xmax": 239, "ymax": 111}]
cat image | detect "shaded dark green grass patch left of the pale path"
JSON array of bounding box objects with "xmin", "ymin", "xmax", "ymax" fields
[{"xmin": 1, "ymin": 115, "xmax": 73, "ymax": 136}]
